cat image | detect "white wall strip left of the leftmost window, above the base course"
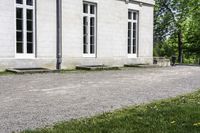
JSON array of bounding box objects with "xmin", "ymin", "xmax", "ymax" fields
[{"xmin": 0, "ymin": 0, "xmax": 15, "ymax": 59}]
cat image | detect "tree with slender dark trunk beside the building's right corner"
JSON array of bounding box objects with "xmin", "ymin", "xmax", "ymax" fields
[{"xmin": 154, "ymin": 0, "xmax": 190, "ymax": 63}]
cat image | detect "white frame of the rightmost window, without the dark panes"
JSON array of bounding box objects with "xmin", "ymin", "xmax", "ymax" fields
[{"xmin": 127, "ymin": 9, "xmax": 139, "ymax": 58}]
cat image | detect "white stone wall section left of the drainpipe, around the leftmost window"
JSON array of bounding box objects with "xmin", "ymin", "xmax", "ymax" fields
[{"xmin": 0, "ymin": 0, "xmax": 56, "ymax": 69}]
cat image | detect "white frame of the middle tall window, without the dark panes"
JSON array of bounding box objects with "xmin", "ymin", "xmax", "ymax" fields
[{"xmin": 82, "ymin": 1, "xmax": 97, "ymax": 58}]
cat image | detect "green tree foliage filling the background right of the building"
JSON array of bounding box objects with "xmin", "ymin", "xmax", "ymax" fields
[{"xmin": 154, "ymin": 0, "xmax": 200, "ymax": 62}]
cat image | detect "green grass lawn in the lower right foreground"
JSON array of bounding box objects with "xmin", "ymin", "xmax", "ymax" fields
[{"xmin": 22, "ymin": 91, "xmax": 200, "ymax": 133}]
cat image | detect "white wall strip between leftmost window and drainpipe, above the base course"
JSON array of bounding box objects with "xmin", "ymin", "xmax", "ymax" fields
[{"xmin": 36, "ymin": 0, "xmax": 56, "ymax": 59}]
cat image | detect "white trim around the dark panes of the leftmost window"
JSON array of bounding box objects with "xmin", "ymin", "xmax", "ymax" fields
[{"xmin": 14, "ymin": 0, "xmax": 36, "ymax": 59}]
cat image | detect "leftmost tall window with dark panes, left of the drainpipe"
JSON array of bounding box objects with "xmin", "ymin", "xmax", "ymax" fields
[{"xmin": 16, "ymin": 0, "xmax": 35, "ymax": 57}]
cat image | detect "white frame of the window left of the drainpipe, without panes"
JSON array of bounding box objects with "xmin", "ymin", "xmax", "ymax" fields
[{"xmin": 14, "ymin": 0, "xmax": 36, "ymax": 59}]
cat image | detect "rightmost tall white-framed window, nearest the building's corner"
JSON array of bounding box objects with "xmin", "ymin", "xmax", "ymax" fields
[{"xmin": 128, "ymin": 10, "xmax": 138, "ymax": 57}]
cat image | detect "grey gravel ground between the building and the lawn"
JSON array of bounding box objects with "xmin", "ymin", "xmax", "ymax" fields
[{"xmin": 0, "ymin": 66, "xmax": 200, "ymax": 133}]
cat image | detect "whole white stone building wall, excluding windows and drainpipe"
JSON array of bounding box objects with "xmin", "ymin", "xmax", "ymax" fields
[{"xmin": 0, "ymin": 0, "xmax": 153, "ymax": 68}]
